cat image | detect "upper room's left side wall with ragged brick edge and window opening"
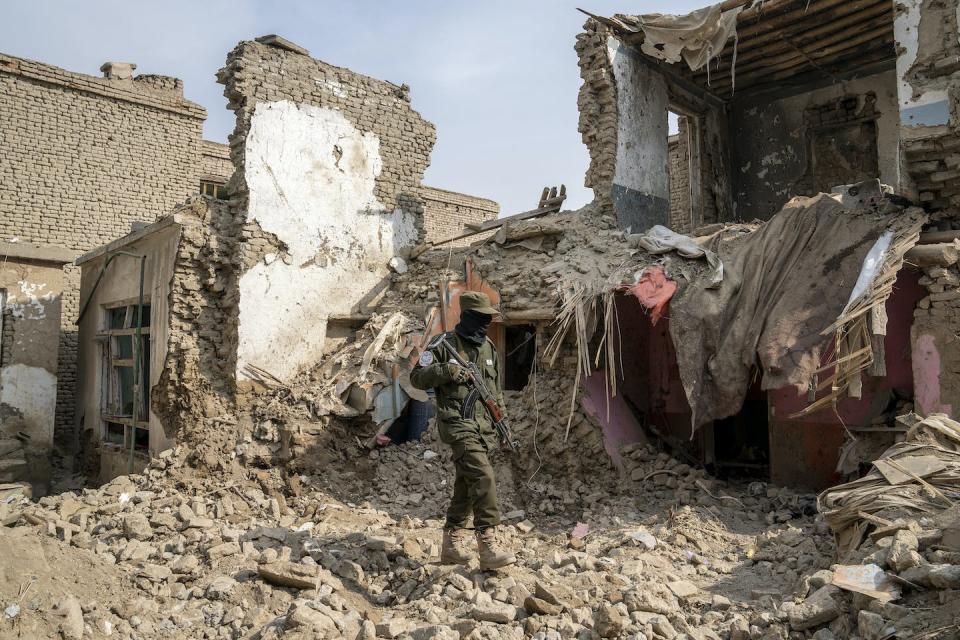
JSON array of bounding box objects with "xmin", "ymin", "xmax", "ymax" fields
[{"xmin": 575, "ymin": 18, "xmax": 733, "ymax": 232}]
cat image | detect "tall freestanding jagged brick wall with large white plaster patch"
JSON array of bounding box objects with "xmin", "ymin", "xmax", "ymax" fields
[{"xmin": 218, "ymin": 37, "xmax": 436, "ymax": 386}]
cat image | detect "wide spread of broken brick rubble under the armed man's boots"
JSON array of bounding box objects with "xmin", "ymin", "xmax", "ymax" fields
[{"xmin": 0, "ymin": 412, "xmax": 860, "ymax": 639}]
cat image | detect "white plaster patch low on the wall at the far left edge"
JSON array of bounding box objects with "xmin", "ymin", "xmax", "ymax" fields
[{"xmin": 0, "ymin": 364, "xmax": 57, "ymax": 448}]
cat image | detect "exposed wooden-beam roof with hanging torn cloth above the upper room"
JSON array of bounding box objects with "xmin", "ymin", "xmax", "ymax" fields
[{"xmin": 588, "ymin": 0, "xmax": 897, "ymax": 100}]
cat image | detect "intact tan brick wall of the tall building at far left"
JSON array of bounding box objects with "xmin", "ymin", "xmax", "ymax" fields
[{"xmin": 0, "ymin": 54, "xmax": 206, "ymax": 442}]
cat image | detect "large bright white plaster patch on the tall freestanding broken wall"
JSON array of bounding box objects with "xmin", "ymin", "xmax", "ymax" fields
[{"xmin": 237, "ymin": 100, "xmax": 417, "ymax": 380}]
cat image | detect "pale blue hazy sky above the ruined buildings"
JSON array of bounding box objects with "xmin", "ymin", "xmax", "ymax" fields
[{"xmin": 0, "ymin": 0, "xmax": 709, "ymax": 215}]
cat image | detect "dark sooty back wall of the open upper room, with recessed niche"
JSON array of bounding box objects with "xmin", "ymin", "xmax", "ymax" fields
[{"xmin": 730, "ymin": 68, "xmax": 900, "ymax": 220}]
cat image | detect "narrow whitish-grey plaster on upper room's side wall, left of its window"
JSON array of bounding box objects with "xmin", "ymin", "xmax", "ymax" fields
[{"xmin": 607, "ymin": 38, "xmax": 670, "ymax": 202}]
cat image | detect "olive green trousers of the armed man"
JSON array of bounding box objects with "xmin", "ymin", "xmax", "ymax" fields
[{"xmin": 446, "ymin": 436, "xmax": 500, "ymax": 529}]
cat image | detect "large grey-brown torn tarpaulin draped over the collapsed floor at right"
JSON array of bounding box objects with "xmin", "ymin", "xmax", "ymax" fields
[{"xmin": 670, "ymin": 194, "xmax": 926, "ymax": 428}]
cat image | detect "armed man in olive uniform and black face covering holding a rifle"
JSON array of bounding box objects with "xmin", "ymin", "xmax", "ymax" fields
[{"xmin": 410, "ymin": 291, "xmax": 517, "ymax": 571}]
